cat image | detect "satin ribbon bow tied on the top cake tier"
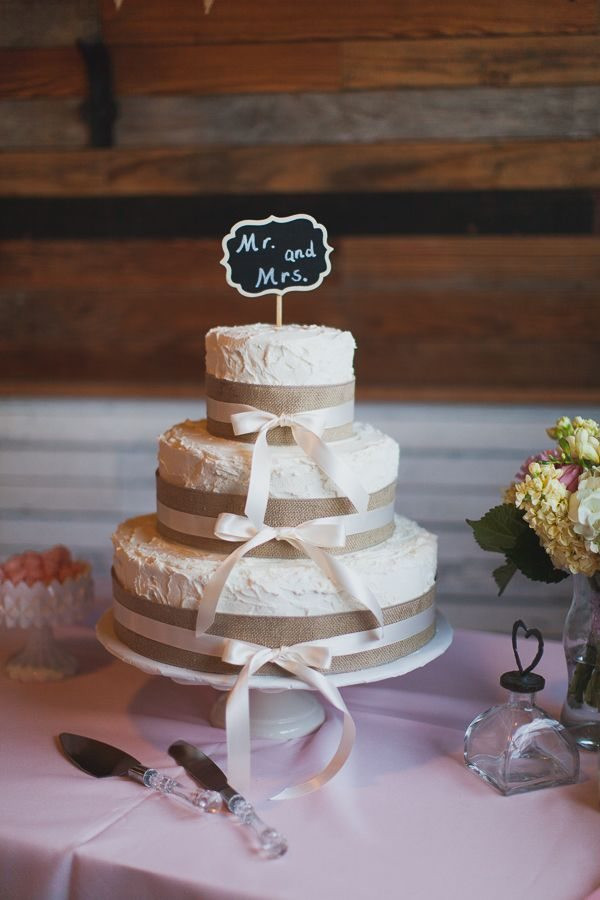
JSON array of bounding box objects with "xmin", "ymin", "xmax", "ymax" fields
[{"xmin": 231, "ymin": 404, "xmax": 369, "ymax": 524}]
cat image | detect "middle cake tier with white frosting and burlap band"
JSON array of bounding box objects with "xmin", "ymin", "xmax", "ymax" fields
[{"xmin": 157, "ymin": 420, "xmax": 399, "ymax": 558}]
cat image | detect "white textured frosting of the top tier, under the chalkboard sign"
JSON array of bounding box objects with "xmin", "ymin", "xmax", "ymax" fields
[{"xmin": 206, "ymin": 323, "xmax": 356, "ymax": 386}]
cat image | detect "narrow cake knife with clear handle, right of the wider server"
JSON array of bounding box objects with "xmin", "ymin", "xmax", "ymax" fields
[{"xmin": 169, "ymin": 741, "xmax": 287, "ymax": 859}]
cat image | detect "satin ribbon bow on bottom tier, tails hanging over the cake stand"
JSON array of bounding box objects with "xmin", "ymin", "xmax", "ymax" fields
[{"xmin": 221, "ymin": 639, "xmax": 356, "ymax": 800}]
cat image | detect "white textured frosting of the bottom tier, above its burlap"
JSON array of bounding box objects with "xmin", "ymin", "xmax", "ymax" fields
[{"xmin": 113, "ymin": 516, "xmax": 437, "ymax": 616}]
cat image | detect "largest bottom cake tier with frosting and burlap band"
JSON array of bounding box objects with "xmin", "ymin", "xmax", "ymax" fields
[{"xmin": 113, "ymin": 516, "xmax": 437, "ymax": 674}]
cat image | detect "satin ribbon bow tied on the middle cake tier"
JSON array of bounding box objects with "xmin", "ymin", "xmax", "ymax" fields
[{"xmin": 196, "ymin": 513, "xmax": 383, "ymax": 637}]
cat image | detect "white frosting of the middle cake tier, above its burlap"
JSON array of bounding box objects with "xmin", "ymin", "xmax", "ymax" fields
[{"xmin": 158, "ymin": 419, "xmax": 399, "ymax": 499}]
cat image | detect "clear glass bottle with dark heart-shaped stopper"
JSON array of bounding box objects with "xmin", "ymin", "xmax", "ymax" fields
[{"xmin": 465, "ymin": 619, "xmax": 579, "ymax": 795}]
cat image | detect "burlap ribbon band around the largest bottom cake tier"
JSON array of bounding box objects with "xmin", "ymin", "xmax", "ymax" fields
[{"xmin": 113, "ymin": 573, "xmax": 435, "ymax": 675}]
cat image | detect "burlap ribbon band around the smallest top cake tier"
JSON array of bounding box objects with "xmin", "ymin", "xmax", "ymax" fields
[{"xmin": 206, "ymin": 375, "xmax": 354, "ymax": 446}]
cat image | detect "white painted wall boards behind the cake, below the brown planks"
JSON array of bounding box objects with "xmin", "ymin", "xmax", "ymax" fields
[{"xmin": 0, "ymin": 398, "xmax": 600, "ymax": 636}]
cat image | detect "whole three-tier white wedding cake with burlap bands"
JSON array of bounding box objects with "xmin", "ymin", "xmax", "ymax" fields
[{"xmin": 113, "ymin": 324, "xmax": 436, "ymax": 675}]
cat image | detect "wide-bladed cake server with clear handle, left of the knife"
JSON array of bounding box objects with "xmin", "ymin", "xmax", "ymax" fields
[{"xmin": 58, "ymin": 731, "xmax": 222, "ymax": 812}]
